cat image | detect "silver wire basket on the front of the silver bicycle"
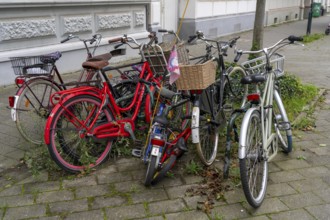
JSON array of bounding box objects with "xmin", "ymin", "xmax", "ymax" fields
[{"xmin": 241, "ymin": 53, "xmax": 285, "ymax": 77}]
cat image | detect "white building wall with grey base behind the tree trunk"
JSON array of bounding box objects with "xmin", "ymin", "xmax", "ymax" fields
[{"xmin": 180, "ymin": 0, "xmax": 306, "ymax": 38}]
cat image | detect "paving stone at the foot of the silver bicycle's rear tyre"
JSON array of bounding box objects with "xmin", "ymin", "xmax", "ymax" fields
[{"xmin": 246, "ymin": 198, "xmax": 289, "ymax": 216}]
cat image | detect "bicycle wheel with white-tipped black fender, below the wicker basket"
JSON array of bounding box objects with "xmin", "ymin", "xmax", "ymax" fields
[{"xmin": 192, "ymin": 83, "xmax": 220, "ymax": 166}]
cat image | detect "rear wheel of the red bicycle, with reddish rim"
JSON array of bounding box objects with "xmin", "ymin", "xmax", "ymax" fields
[{"xmin": 48, "ymin": 95, "xmax": 114, "ymax": 173}]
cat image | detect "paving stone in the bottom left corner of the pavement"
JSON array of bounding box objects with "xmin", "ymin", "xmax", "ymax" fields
[{"xmin": 3, "ymin": 205, "xmax": 46, "ymax": 220}]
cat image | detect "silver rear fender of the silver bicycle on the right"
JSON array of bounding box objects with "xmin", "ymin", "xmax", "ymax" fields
[{"xmin": 238, "ymin": 107, "xmax": 258, "ymax": 159}]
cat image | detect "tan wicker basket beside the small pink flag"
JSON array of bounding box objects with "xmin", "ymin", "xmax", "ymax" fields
[{"xmin": 175, "ymin": 60, "xmax": 216, "ymax": 90}]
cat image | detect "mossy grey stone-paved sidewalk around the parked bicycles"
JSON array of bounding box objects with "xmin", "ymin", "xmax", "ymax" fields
[{"xmin": 0, "ymin": 16, "xmax": 330, "ymax": 220}]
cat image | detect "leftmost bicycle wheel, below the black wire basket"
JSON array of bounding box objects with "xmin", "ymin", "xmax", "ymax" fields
[{"xmin": 16, "ymin": 79, "xmax": 60, "ymax": 144}]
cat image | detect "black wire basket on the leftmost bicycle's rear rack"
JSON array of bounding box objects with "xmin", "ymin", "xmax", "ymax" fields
[{"xmin": 9, "ymin": 56, "xmax": 54, "ymax": 76}]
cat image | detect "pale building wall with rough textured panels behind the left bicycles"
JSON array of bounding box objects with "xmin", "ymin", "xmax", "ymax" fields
[{"xmin": 0, "ymin": 0, "xmax": 159, "ymax": 86}]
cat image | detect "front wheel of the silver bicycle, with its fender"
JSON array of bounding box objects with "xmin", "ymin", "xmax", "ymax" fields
[{"xmin": 273, "ymin": 90, "xmax": 292, "ymax": 153}]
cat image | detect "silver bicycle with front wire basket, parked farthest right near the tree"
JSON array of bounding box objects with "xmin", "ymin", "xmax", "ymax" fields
[{"xmin": 235, "ymin": 36, "xmax": 303, "ymax": 208}]
